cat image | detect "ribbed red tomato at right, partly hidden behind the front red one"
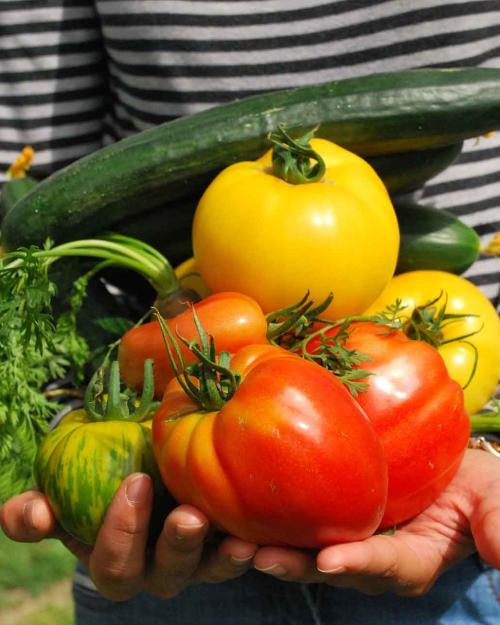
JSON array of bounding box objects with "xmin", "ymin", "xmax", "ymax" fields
[{"xmin": 308, "ymin": 323, "xmax": 470, "ymax": 528}]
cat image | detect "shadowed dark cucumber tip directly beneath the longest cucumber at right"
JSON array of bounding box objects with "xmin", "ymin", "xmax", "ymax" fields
[{"xmin": 366, "ymin": 142, "xmax": 463, "ymax": 194}]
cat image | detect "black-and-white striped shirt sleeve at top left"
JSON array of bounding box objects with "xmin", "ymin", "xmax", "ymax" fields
[{"xmin": 0, "ymin": 0, "xmax": 108, "ymax": 182}]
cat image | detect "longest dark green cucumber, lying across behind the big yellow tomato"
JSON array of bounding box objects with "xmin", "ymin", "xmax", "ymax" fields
[{"xmin": 2, "ymin": 68, "xmax": 500, "ymax": 249}]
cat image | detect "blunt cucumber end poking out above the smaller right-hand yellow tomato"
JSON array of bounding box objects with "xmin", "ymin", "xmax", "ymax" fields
[{"xmin": 394, "ymin": 199, "xmax": 480, "ymax": 274}]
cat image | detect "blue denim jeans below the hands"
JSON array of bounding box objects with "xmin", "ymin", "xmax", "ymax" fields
[{"xmin": 73, "ymin": 556, "xmax": 500, "ymax": 625}]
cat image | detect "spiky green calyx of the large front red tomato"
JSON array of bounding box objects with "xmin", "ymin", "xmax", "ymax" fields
[{"xmin": 153, "ymin": 306, "xmax": 241, "ymax": 411}]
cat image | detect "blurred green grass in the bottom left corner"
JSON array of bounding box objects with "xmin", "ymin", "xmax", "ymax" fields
[{"xmin": 0, "ymin": 531, "xmax": 75, "ymax": 625}]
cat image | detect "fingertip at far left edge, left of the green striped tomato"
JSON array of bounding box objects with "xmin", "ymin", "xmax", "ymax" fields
[{"xmin": 0, "ymin": 490, "xmax": 56, "ymax": 542}]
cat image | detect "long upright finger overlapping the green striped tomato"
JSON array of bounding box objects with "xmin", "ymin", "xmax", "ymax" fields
[{"xmin": 89, "ymin": 473, "xmax": 153, "ymax": 601}]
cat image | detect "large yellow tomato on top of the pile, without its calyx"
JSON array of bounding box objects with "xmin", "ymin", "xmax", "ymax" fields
[{"xmin": 193, "ymin": 139, "xmax": 399, "ymax": 318}]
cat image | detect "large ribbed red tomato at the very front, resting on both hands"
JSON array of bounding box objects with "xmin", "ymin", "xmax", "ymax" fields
[{"xmin": 153, "ymin": 345, "xmax": 387, "ymax": 548}]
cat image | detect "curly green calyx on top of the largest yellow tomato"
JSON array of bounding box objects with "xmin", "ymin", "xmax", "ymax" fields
[{"xmin": 269, "ymin": 124, "xmax": 326, "ymax": 184}]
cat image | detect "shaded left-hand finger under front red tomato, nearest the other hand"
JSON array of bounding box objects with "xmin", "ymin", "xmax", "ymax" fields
[{"xmin": 193, "ymin": 536, "xmax": 257, "ymax": 583}]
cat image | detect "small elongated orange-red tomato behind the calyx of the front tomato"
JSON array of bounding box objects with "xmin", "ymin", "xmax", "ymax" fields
[{"xmin": 118, "ymin": 292, "xmax": 267, "ymax": 397}]
